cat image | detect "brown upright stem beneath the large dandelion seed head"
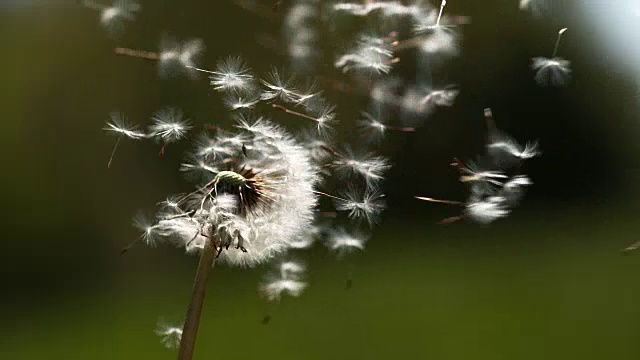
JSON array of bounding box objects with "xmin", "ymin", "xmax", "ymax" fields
[{"xmin": 178, "ymin": 237, "xmax": 216, "ymax": 360}]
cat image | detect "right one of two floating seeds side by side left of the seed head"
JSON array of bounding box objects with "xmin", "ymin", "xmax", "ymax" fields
[{"xmin": 148, "ymin": 108, "xmax": 191, "ymax": 156}]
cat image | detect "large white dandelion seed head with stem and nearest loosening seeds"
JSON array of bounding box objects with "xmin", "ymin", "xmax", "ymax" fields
[{"xmin": 113, "ymin": 55, "xmax": 390, "ymax": 359}]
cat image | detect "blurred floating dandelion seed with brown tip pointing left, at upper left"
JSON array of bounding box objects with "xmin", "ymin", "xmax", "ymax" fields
[{"xmin": 115, "ymin": 36, "xmax": 205, "ymax": 79}]
